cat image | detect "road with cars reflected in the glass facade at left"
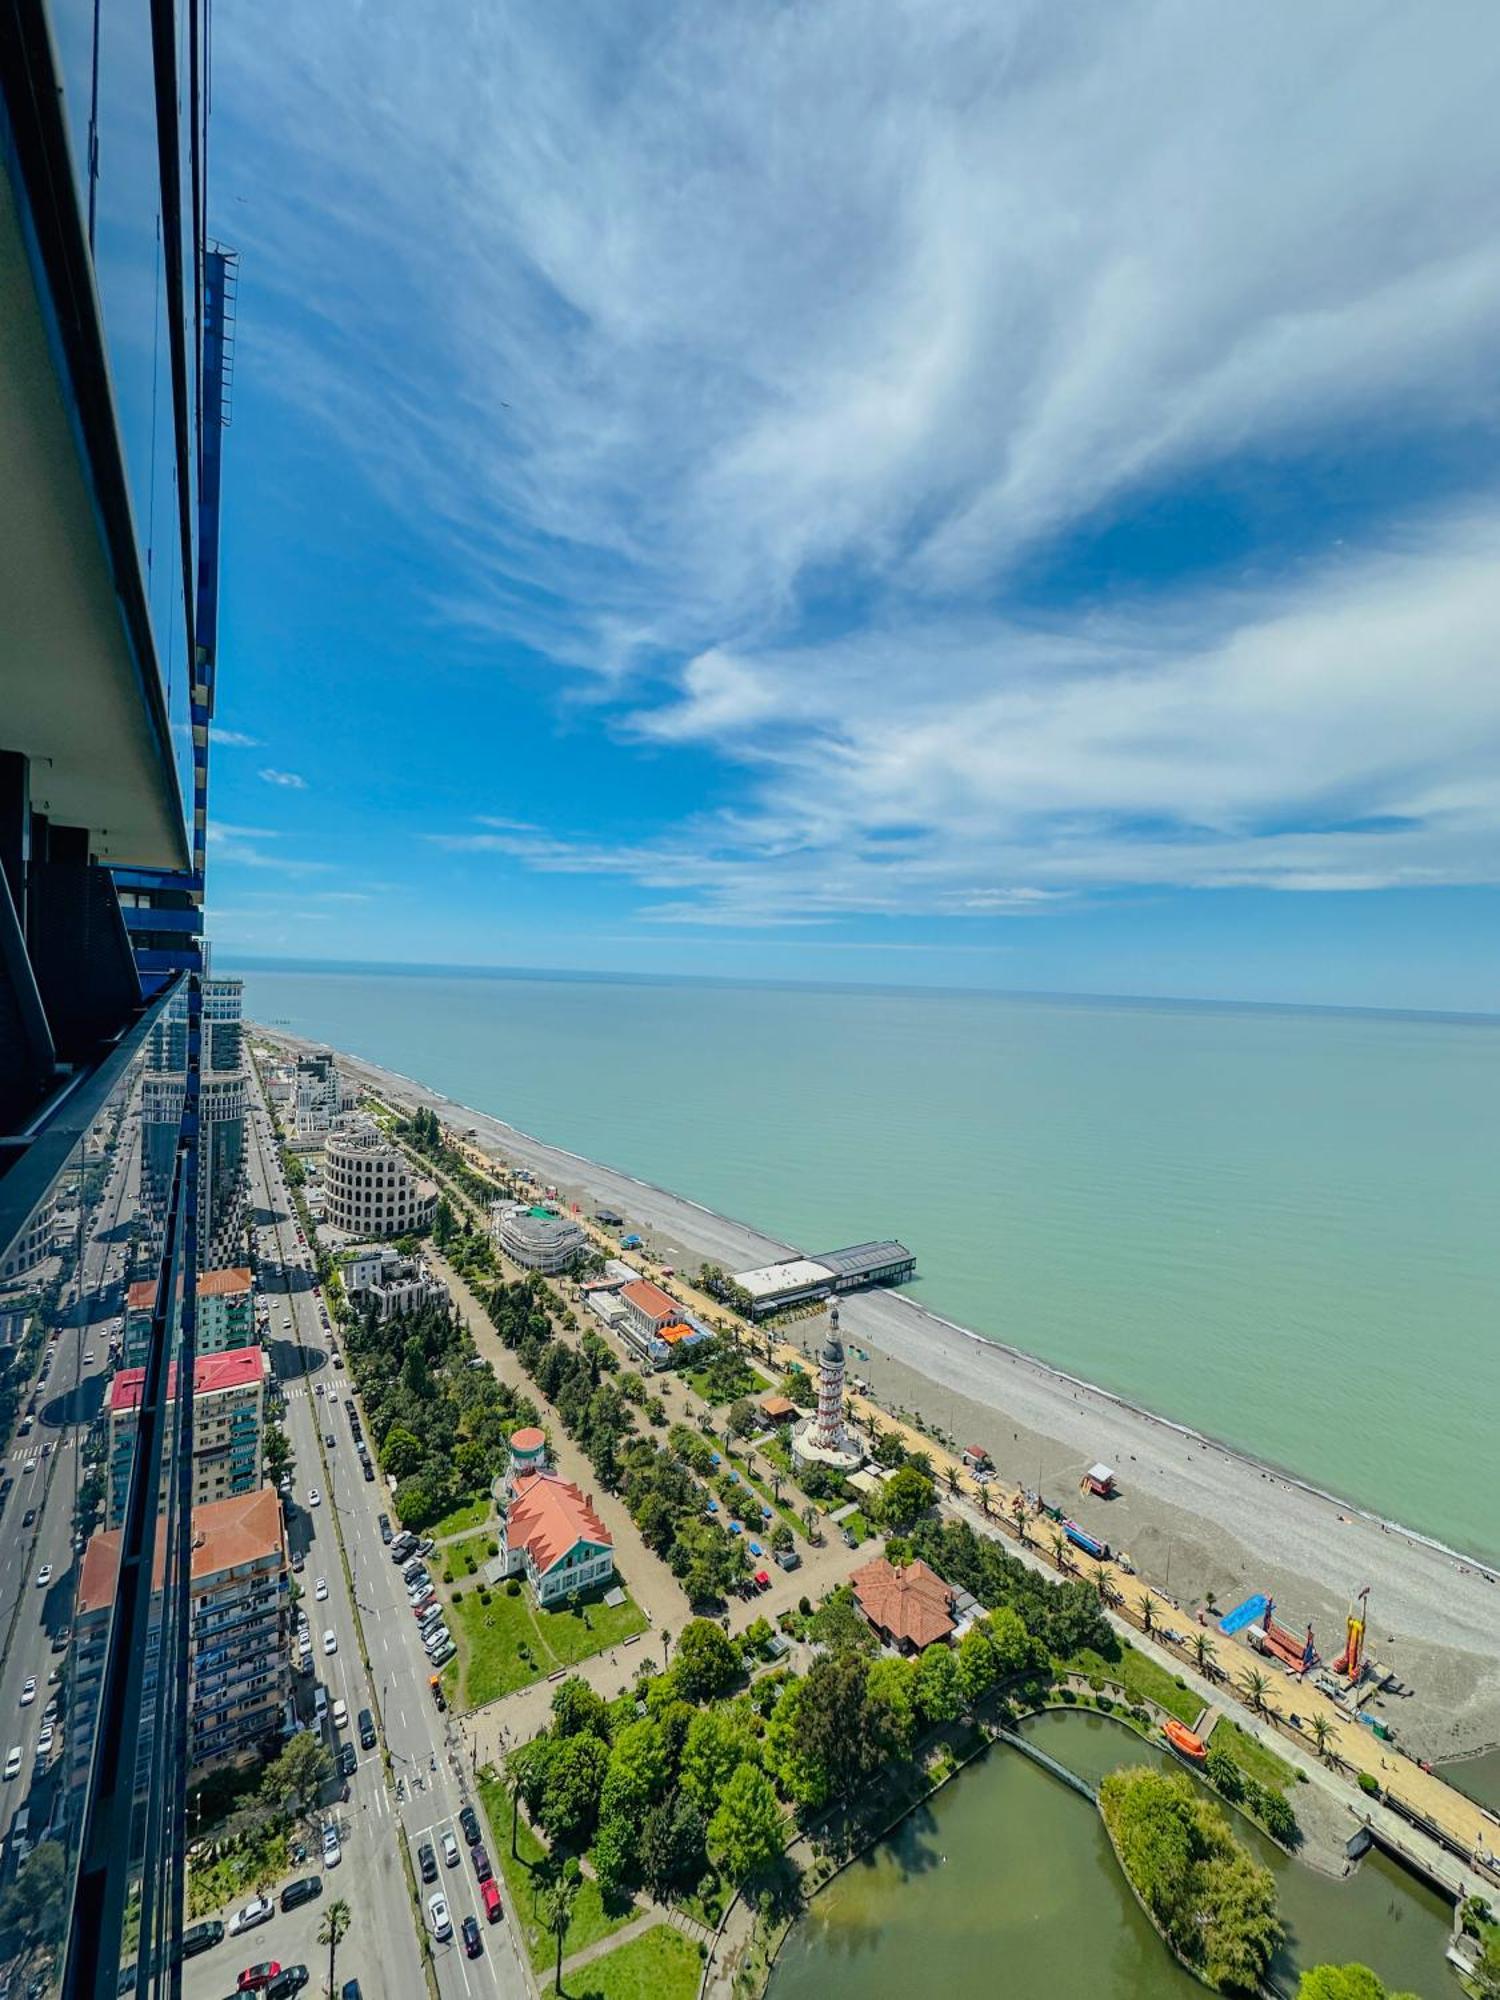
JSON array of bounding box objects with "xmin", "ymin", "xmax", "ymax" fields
[{"xmin": 0, "ymin": 1114, "xmax": 140, "ymax": 1856}]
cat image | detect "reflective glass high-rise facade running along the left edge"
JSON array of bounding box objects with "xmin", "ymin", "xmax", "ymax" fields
[{"xmin": 0, "ymin": 0, "xmax": 244, "ymax": 2000}]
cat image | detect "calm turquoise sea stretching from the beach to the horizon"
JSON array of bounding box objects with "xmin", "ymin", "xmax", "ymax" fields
[{"xmin": 232, "ymin": 966, "xmax": 1500, "ymax": 1558}]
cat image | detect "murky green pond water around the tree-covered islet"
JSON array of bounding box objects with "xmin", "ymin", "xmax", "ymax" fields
[{"xmin": 770, "ymin": 1714, "xmax": 1458, "ymax": 2000}]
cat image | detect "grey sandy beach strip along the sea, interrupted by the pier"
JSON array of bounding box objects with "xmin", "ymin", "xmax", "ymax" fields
[{"xmin": 270, "ymin": 1030, "xmax": 1500, "ymax": 1762}]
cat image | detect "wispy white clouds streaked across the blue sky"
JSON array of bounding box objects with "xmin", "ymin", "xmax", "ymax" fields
[{"xmin": 216, "ymin": 0, "xmax": 1500, "ymax": 924}]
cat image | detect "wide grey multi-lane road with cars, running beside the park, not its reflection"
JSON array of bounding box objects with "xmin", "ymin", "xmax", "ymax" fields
[{"xmin": 184, "ymin": 1078, "xmax": 530, "ymax": 2000}]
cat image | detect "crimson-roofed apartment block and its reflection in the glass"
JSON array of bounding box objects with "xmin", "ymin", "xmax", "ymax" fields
[{"xmin": 106, "ymin": 1346, "xmax": 270, "ymax": 1528}]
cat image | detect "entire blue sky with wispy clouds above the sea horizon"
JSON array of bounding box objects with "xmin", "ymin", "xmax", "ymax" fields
[{"xmin": 210, "ymin": 0, "xmax": 1500, "ymax": 1010}]
